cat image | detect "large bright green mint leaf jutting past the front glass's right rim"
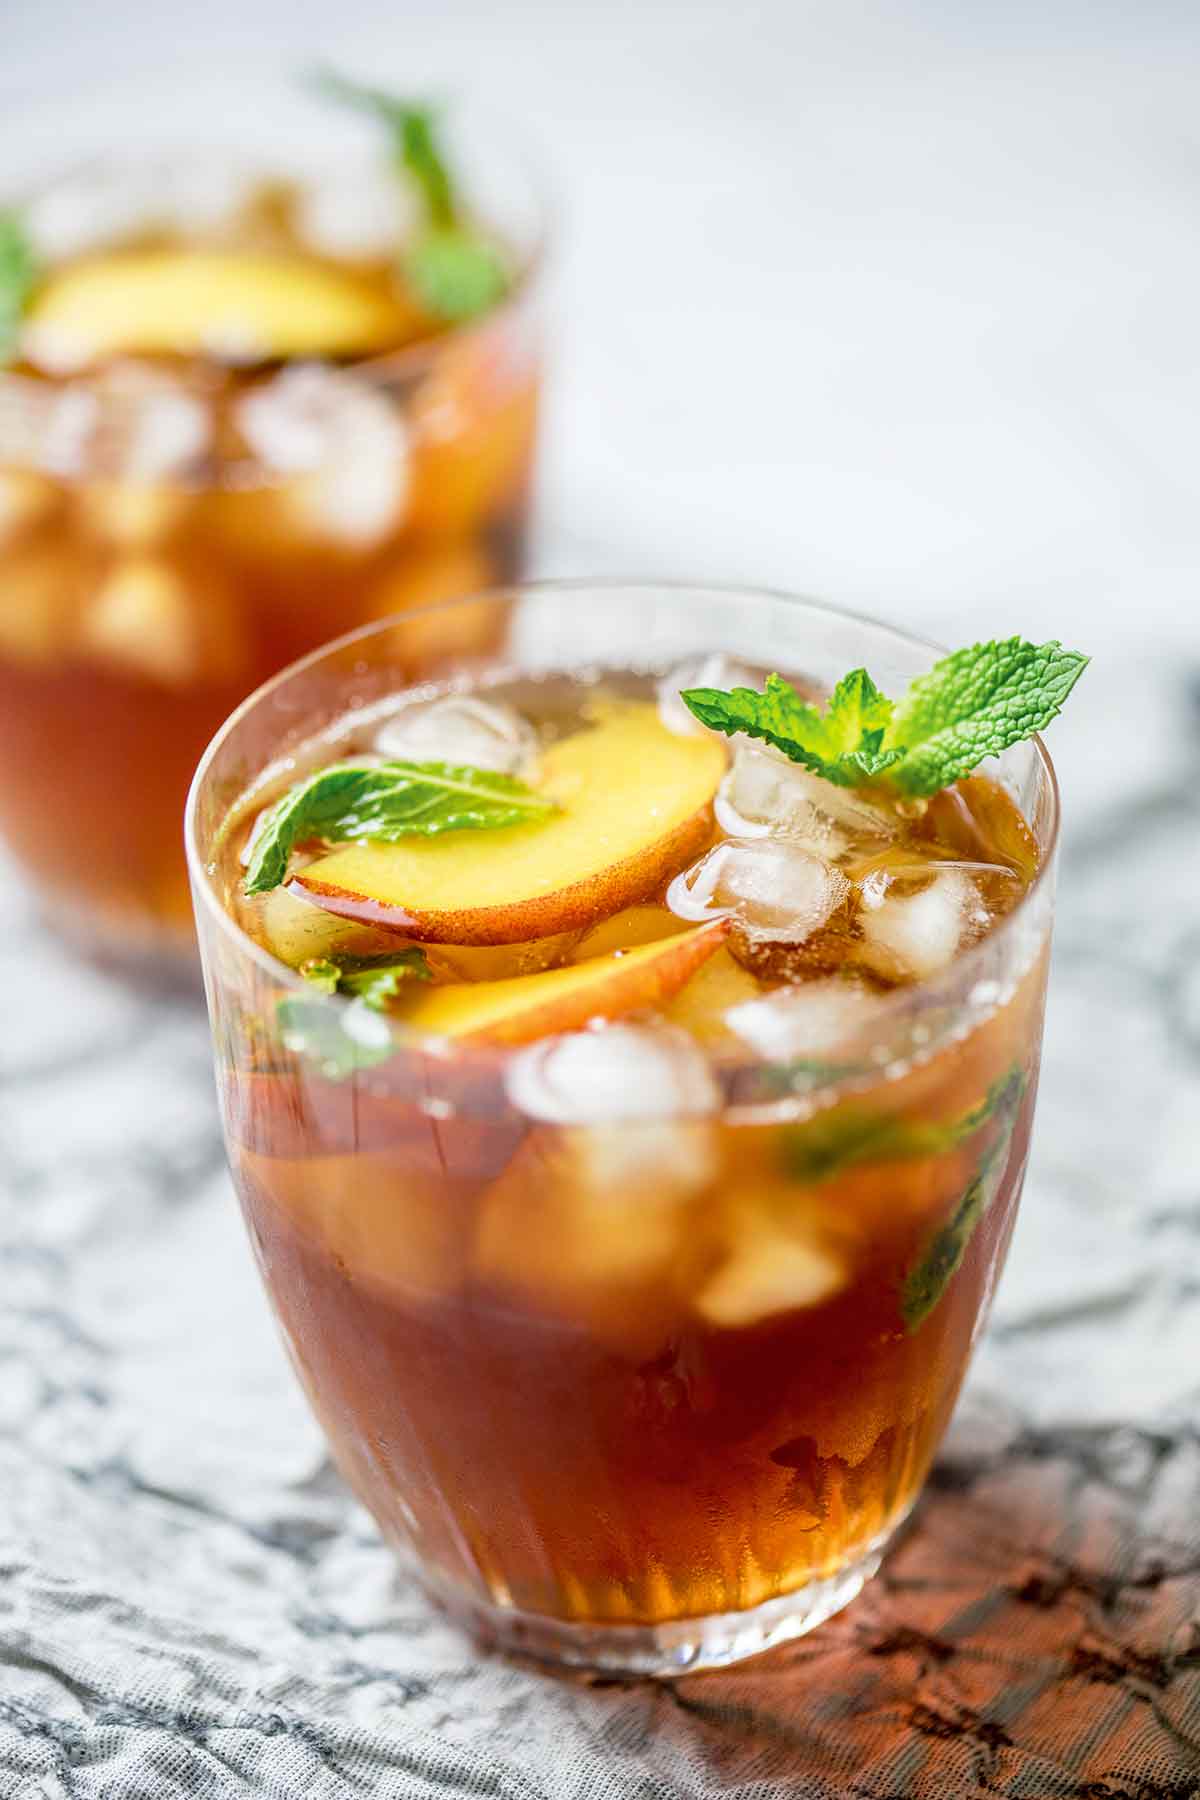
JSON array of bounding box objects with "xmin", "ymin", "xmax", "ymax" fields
[{"xmin": 885, "ymin": 637, "xmax": 1088, "ymax": 796}]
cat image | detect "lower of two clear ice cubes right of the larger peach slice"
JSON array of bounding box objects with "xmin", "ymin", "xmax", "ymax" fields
[{"xmin": 667, "ymin": 837, "xmax": 849, "ymax": 943}]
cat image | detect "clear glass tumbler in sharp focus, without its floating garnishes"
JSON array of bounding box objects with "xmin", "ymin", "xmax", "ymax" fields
[{"xmin": 187, "ymin": 581, "xmax": 1058, "ymax": 1674}]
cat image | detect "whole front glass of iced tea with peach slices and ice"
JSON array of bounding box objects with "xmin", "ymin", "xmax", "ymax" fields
[{"xmin": 189, "ymin": 585, "xmax": 1058, "ymax": 1674}]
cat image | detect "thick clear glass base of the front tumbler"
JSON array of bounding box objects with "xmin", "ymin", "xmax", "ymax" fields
[{"xmin": 426, "ymin": 1532, "xmax": 892, "ymax": 1679}]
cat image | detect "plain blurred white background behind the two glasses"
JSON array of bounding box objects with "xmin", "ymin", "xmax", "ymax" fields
[{"xmin": 0, "ymin": 0, "xmax": 1200, "ymax": 824}]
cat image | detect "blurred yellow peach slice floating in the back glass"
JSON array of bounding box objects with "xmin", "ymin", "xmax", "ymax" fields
[{"xmin": 25, "ymin": 250, "xmax": 412, "ymax": 369}]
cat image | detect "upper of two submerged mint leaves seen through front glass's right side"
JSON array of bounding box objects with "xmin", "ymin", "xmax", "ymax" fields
[{"xmin": 781, "ymin": 1067, "xmax": 1025, "ymax": 1181}]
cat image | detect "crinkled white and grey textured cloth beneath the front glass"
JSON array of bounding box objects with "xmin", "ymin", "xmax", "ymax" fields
[{"xmin": 0, "ymin": 676, "xmax": 1200, "ymax": 1800}]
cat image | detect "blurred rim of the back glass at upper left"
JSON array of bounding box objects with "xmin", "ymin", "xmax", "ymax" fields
[{"xmin": 0, "ymin": 106, "xmax": 561, "ymax": 412}]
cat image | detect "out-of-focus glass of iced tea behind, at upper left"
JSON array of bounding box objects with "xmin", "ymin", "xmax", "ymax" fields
[{"xmin": 0, "ymin": 112, "xmax": 543, "ymax": 976}]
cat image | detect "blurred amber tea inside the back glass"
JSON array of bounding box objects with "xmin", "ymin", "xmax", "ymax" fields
[{"xmin": 0, "ymin": 202, "xmax": 538, "ymax": 970}]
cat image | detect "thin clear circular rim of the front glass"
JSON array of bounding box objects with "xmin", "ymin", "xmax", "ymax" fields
[{"xmin": 184, "ymin": 576, "xmax": 1061, "ymax": 1120}]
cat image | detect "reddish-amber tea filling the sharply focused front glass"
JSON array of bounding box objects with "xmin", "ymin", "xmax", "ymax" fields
[{"xmin": 225, "ymin": 676, "xmax": 1045, "ymax": 1625}]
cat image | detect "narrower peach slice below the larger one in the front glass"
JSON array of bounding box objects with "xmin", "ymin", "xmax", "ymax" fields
[{"xmin": 403, "ymin": 920, "xmax": 727, "ymax": 1044}]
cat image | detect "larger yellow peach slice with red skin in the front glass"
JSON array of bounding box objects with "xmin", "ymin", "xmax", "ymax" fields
[{"xmin": 295, "ymin": 704, "xmax": 725, "ymax": 943}]
